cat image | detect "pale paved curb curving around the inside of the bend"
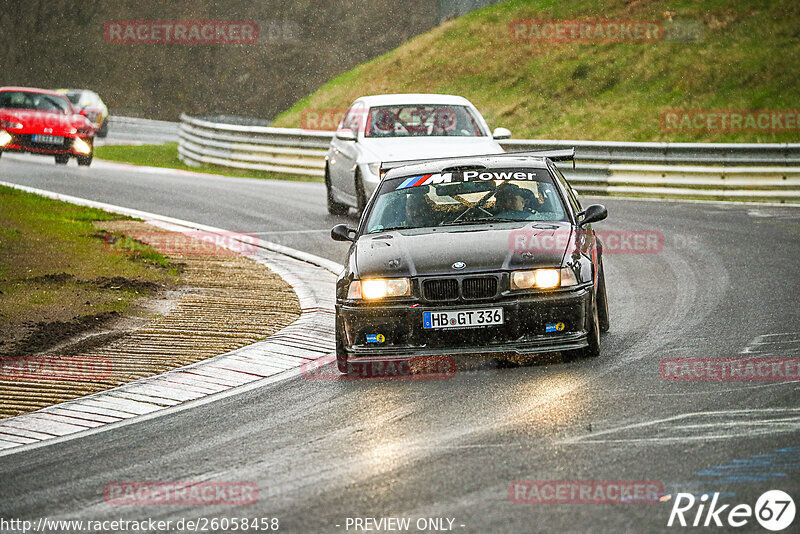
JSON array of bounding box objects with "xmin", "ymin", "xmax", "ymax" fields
[{"xmin": 0, "ymin": 182, "xmax": 342, "ymax": 456}]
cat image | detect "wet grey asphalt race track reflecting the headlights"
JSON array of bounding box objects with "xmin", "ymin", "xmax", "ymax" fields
[{"xmin": 0, "ymin": 156, "xmax": 800, "ymax": 533}]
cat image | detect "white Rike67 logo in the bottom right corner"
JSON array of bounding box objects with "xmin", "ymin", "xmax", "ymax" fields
[{"xmin": 667, "ymin": 490, "xmax": 795, "ymax": 532}]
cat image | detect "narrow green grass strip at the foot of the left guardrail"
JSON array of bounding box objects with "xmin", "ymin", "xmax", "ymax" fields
[{"xmin": 94, "ymin": 143, "xmax": 322, "ymax": 182}]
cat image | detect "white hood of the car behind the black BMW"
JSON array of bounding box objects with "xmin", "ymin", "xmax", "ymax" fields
[{"xmin": 359, "ymin": 136, "xmax": 503, "ymax": 163}]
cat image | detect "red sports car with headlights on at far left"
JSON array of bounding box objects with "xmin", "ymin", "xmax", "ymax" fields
[{"xmin": 0, "ymin": 87, "xmax": 94, "ymax": 166}]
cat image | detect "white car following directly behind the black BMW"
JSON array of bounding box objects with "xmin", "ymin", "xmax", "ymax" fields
[{"xmin": 325, "ymin": 94, "xmax": 511, "ymax": 215}]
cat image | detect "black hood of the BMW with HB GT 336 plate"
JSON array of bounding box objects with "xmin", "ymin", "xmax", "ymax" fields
[{"xmin": 354, "ymin": 222, "xmax": 575, "ymax": 278}]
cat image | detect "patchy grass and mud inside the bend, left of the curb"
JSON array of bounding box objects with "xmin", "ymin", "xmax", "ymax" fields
[{"xmin": 0, "ymin": 187, "xmax": 178, "ymax": 355}]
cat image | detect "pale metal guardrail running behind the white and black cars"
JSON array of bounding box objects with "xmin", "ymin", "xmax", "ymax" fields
[{"xmin": 178, "ymin": 115, "xmax": 800, "ymax": 203}]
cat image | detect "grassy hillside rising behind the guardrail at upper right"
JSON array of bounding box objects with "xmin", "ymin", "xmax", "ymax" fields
[{"xmin": 274, "ymin": 0, "xmax": 800, "ymax": 142}]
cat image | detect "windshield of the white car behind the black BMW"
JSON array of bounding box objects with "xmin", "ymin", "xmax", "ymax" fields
[{"xmin": 364, "ymin": 105, "xmax": 486, "ymax": 137}]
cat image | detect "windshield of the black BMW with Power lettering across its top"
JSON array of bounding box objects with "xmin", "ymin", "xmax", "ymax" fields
[{"xmin": 366, "ymin": 169, "xmax": 568, "ymax": 233}]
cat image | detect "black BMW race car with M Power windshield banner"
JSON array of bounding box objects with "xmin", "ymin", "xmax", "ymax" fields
[{"xmin": 331, "ymin": 150, "xmax": 608, "ymax": 373}]
